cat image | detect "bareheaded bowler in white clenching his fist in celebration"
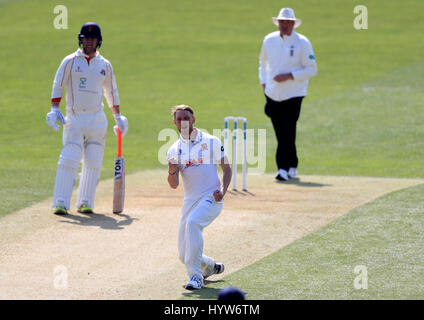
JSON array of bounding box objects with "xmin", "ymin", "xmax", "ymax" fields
[{"xmin": 167, "ymin": 105, "xmax": 231, "ymax": 290}]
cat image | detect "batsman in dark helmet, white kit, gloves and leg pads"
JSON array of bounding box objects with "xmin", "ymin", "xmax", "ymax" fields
[{"xmin": 46, "ymin": 22, "xmax": 128, "ymax": 215}]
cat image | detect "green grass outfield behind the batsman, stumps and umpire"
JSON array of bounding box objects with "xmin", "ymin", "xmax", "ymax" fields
[{"xmin": 0, "ymin": 0, "xmax": 424, "ymax": 298}]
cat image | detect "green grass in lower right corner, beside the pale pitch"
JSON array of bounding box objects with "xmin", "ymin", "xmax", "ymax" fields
[{"xmin": 183, "ymin": 184, "xmax": 424, "ymax": 300}]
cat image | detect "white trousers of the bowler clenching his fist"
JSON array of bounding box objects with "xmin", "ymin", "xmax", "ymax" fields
[{"xmin": 178, "ymin": 195, "xmax": 223, "ymax": 278}]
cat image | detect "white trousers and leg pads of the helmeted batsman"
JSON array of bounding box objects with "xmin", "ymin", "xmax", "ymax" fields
[{"xmin": 53, "ymin": 110, "xmax": 108, "ymax": 209}]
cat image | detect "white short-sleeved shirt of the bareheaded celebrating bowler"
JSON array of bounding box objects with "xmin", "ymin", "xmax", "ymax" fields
[{"xmin": 167, "ymin": 129, "xmax": 225, "ymax": 201}]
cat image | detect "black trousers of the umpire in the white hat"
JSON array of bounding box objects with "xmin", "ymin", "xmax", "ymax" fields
[{"xmin": 265, "ymin": 95, "xmax": 304, "ymax": 170}]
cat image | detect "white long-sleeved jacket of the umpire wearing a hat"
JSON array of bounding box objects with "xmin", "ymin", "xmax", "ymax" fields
[{"xmin": 259, "ymin": 30, "xmax": 318, "ymax": 101}]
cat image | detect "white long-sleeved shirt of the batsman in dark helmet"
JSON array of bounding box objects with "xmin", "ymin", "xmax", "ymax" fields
[{"xmin": 52, "ymin": 49, "xmax": 119, "ymax": 113}]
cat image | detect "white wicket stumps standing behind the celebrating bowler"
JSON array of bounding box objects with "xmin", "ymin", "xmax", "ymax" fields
[{"xmin": 224, "ymin": 117, "xmax": 247, "ymax": 191}]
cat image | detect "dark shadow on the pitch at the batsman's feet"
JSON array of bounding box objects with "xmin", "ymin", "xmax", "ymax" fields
[{"xmin": 60, "ymin": 213, "xmax": 137, "ymax": 230}]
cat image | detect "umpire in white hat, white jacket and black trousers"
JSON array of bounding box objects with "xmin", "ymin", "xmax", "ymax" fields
[{"xmin": 259, "ymin": 8, "xmax": 317, "ymax": 181}]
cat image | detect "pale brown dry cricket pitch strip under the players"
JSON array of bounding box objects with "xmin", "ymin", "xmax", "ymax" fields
[{"xmin": 0, "ymin": 170, "xmax": 423, "ymax": 299}]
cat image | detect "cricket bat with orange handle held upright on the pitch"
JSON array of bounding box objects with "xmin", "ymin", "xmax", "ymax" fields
[{"xmin": 113, "ymin": 127, "xmax": 125, "ymax": 213}]
